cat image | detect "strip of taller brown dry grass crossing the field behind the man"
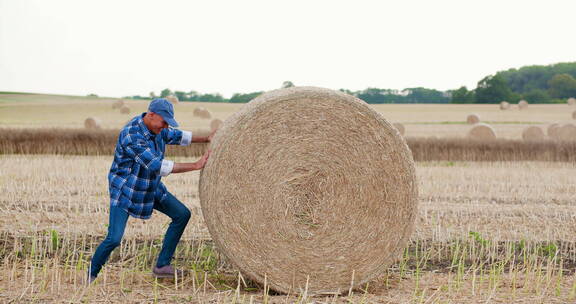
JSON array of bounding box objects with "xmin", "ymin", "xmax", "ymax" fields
[{"xmin": 0, "ymin": 129, "xmax": 576, "ymax": 162}]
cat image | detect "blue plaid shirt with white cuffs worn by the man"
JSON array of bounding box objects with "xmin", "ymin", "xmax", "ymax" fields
[{"xmin": 108, "ymin": 113, "xmax": 192, "ymax": 219}]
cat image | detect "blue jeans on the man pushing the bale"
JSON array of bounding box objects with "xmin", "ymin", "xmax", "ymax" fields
[{"xmin": 90, "ymin": 193, "xmax": 190, "ymax": 276}]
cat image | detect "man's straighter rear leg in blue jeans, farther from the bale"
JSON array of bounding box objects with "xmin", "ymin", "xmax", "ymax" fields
[{"xmin": 90, "ymin": 207, "xmax": 128, "ymax": 277}]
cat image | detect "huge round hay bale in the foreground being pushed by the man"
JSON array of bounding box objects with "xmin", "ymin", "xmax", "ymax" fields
[{"xmin": 199, "ymin": 87, "xmax": 417, "ymax": 294}]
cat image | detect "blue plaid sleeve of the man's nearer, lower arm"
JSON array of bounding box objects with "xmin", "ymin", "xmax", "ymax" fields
[{"xmin": 123, "ymin": 134, "xmax": 162, "ymax": 174}]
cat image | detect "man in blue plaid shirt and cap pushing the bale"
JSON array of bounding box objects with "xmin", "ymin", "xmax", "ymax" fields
[{"xmin": 88, "ymin": 98, "xmax": 212, "ymax": 283}]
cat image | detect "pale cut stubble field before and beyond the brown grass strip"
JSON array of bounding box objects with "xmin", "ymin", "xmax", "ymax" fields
[{"xmin": 0, "ymin": 94, "xmax": 576, "ymax": 303}]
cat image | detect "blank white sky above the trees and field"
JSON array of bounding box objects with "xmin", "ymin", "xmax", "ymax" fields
[{"xmin": 0, "ymin": 0, "xmax": 576, "ymax": 97}]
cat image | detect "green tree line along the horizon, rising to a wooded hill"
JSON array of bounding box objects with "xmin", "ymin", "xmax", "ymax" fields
[{"xmin": 125, "ymin": 62, "xmax": 576, "ymax": 104}]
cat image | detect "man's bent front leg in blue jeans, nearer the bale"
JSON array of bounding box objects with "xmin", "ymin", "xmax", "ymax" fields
[{"xmin": 154, "ymin": 192, "xmax": 190, "ymax": 268}]
